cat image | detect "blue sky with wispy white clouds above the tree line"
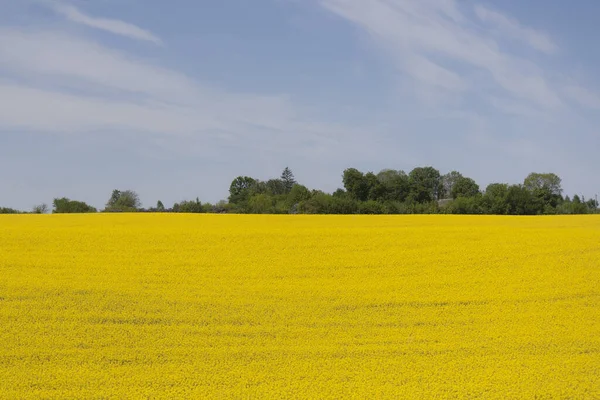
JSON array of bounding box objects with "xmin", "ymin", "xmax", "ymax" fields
[{"xmin": 0, "ymin": 0, "xmax": 600, "ymax": 209}]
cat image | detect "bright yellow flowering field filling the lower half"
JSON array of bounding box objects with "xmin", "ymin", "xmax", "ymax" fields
[{"xmin": 0, "ymin": 214, "xmax": 600, "ymax": 399}]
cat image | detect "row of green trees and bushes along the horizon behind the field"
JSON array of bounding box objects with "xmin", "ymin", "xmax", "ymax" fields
[{"xmin": 0, "ymin": 166, "xmax": 600, "ymax": 215}]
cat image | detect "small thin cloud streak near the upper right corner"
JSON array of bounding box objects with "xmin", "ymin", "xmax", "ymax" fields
[{"xmin": 475, "ymin": 5, "xmax": 558, "ymax": 54}]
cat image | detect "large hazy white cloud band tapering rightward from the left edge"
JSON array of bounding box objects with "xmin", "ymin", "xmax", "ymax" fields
[{"xmin": 0, "ymin": 29, "xmax": 376, "ymax": 162}]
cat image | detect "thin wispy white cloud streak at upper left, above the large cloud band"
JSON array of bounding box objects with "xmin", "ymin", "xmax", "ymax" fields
[{"xmin": 51, "ymin": 3, "xmax": 163, "ymax": 45}]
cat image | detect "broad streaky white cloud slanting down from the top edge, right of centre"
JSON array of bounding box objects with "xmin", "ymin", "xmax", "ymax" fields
[{"xmin": 320, "ymin": 0, "xmax": 561, "ymax": 109}]
